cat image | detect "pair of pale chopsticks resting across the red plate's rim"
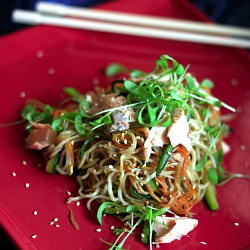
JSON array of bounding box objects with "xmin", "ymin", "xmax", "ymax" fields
[{"xmin": 12, "ymin": 2, "xmax": 250, "ymax": 48}]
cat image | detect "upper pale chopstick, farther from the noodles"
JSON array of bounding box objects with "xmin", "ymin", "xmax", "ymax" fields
[{"xmin": 36, "ymin": 2, "xmax": 250, "ymax": 38}]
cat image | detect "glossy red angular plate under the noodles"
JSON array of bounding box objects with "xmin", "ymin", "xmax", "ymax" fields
[{"xmin": 0, "ymin": 0, "xmax": 250, "ymax": 250}]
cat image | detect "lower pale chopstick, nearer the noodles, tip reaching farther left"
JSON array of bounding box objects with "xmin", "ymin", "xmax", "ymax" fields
[{"xmin": 12, "ymin": 9, "xmax": 250, "ymax": 48}]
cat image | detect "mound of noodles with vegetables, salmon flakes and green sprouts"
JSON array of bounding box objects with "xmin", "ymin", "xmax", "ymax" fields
[{"xmin": 22, "ymin": 55, "xmax": 234, "ymax": 249}]
